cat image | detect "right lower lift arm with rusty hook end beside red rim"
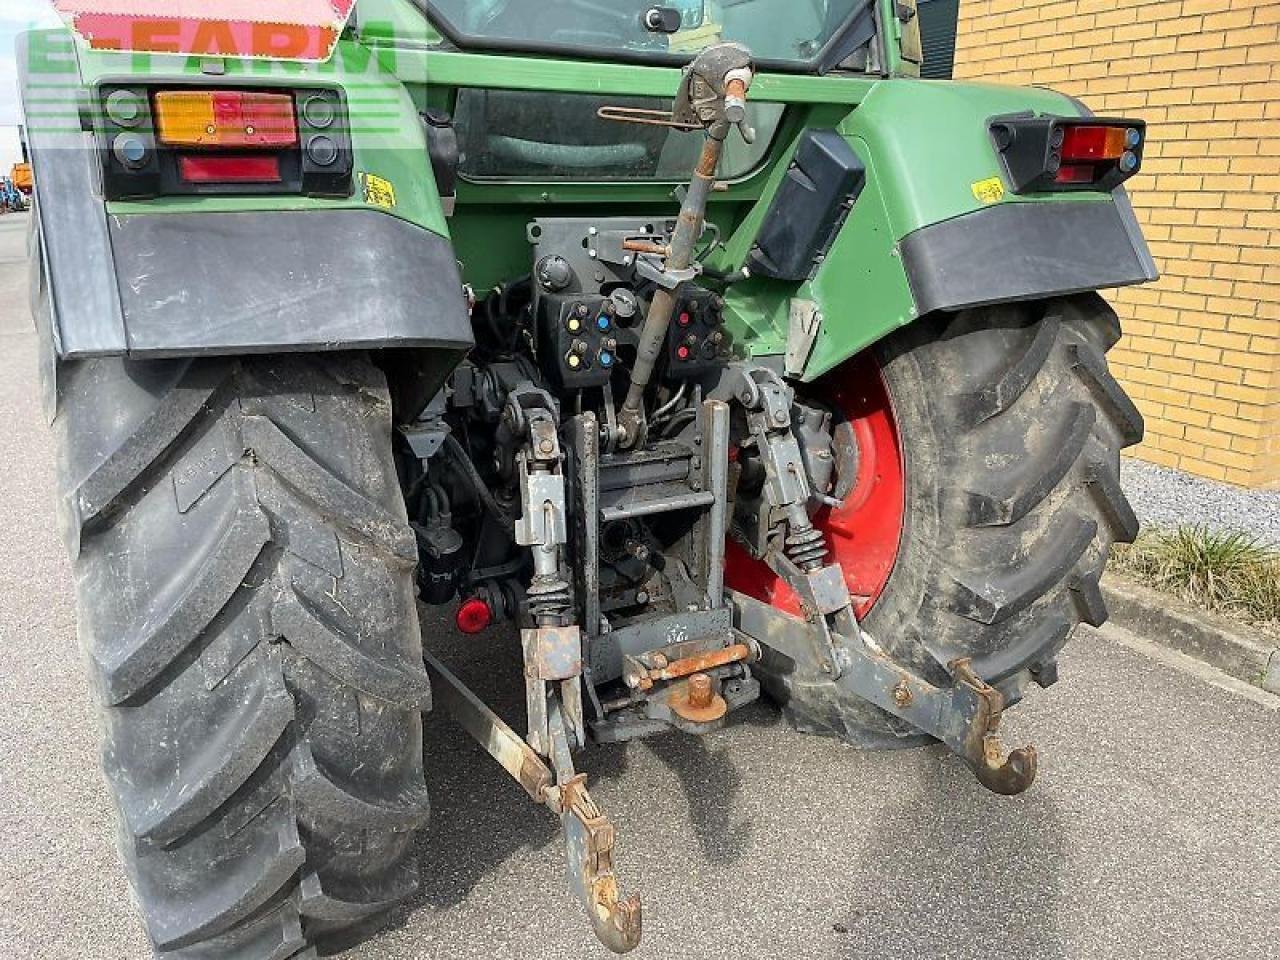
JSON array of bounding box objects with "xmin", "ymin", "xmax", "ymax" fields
[{"xmin": 731, "ymin": 593, "xmax": 1037, "ymax": 796}]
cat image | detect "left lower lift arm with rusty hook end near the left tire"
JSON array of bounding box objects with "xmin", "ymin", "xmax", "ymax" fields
[{"xmin": 422, "ymin": 652, "xmax": 643, "ymax": 954}]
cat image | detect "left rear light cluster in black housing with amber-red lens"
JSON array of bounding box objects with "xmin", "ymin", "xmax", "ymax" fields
[{"xmin": 95, "ymin": 87, "xmax": 353, "ymax": 200}]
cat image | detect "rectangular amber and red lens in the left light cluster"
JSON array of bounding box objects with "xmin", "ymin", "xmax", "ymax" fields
[{"xmin": 155, "ymin": 90, "xmax": 298, "ymax": 148}]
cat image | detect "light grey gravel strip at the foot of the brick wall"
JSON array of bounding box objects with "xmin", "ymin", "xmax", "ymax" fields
[{"xmin": 1120, "ymin": 458, "xmax": 1280, "ymax": 548}]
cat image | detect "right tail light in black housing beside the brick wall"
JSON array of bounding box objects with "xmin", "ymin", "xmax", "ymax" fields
[{"xmin": 991, "ymin": 115, "xmax": 1147, "ymax": 193}]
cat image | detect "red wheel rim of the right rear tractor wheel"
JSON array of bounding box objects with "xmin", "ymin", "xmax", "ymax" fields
[{"xmin": 724, "ymin": 352, "xmax": 906, "ymax": 620}]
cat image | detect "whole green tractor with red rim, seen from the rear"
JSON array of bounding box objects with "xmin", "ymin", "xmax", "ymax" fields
[{"xmin": 19, "ymin": 0, "xmax": 1156, "ymax": 960}]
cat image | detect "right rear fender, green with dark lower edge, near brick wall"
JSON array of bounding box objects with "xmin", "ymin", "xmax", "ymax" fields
[{"xmin": 796, "ymin": 79, "xmax": 1157, "ymax": 380}]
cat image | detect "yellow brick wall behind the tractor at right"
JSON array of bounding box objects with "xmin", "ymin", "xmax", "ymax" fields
[{"xmin": 955, "ymin": 0, "xmax": 1280, "ymax": 486}]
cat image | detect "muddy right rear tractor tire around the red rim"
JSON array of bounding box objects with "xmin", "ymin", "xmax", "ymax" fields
[{"xmin": 764, "ymin": 294, "xmax": 1143, "ymax": 748}]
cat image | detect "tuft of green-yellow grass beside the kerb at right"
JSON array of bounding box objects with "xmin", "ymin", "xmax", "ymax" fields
[{"xmin": 1112, "ymin": 526, "xmax": 1280, "ymax": 626}]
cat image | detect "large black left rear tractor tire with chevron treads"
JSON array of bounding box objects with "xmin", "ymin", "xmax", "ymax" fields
[{"xmin": 55, "ymin": 356, "xmax": 430, "ymax": 960}]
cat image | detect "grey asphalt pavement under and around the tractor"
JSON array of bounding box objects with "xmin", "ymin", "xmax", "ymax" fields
[{"xmin": 0, "ymin": 216, "xmax": 1280, "ymax": 960}]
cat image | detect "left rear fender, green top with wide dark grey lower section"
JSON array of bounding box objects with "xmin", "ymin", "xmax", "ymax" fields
[{"xmin": 18, "ymin": 31, "xmax": 472, "ymax": 417}]
